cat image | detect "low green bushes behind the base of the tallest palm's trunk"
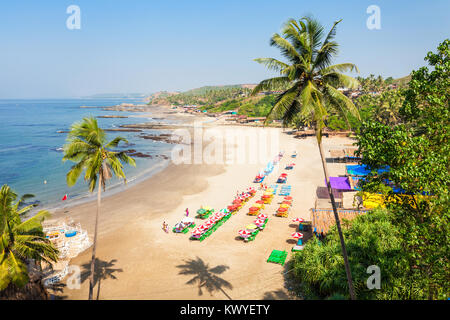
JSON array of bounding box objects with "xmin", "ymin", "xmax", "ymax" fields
[{"xmin": 292, "ymin": 210, "xmax": 408, "ymax": 299}]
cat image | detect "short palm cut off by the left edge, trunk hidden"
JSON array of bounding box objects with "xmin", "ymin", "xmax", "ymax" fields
[{"xmin": 0, "ymin": 184, "xmax": 58, "ymax": 291}]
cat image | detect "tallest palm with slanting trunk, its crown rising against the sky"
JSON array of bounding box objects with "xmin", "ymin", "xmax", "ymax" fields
[{"xmin": 252, "ymin": 17, "xmax": 359, "ymax": 299}]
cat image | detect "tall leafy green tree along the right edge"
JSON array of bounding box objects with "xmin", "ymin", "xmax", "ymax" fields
[{"xmin": 358, "ymin": 39, "xmax": 450, "ymax": 299}]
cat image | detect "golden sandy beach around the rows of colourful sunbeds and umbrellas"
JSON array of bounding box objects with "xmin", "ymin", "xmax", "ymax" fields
[{"xmin": 52, "ymin": 125, "xmax": 352, "ymax": 300}]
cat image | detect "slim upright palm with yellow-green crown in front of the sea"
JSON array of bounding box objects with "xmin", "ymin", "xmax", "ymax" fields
[{"xmin": 63, "ymin": 117, "xmax": 136, "ymax": 300}]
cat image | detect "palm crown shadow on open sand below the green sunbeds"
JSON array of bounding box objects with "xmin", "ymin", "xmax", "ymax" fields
[{"xmin": 177, "ymin": 257, "xmax": 233, "ymax": 300}]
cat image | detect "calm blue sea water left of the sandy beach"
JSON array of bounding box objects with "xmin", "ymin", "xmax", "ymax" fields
[{"xmin": 0, "ymin": 99, "xmax": 173, "ymax": 208}]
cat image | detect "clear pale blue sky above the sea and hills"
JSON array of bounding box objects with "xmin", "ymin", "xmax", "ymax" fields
[{"xmin": 0, "ymin": 0, "xmax": 450, "ymax": 98}]
